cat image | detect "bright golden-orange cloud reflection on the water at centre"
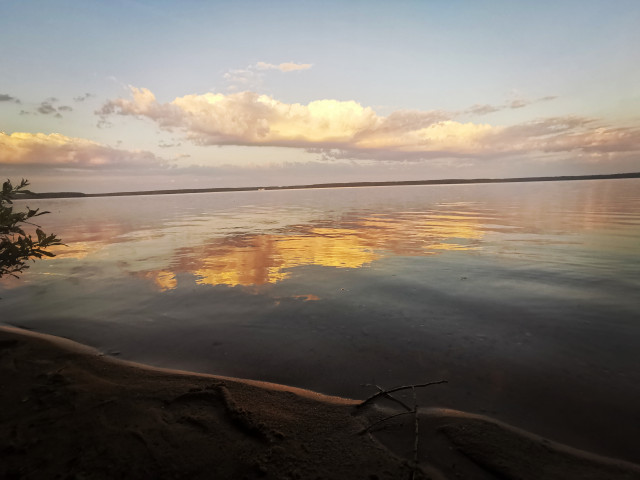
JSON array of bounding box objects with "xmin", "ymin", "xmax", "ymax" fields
[{"xmin": 159, "ymin": 216, "xmax": 483, "ymax": 290}]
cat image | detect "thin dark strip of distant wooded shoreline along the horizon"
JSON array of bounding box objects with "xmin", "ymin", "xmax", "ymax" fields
[{"xmin": 16, "ymin": 172, "xmax": 640, "ymax": 199}]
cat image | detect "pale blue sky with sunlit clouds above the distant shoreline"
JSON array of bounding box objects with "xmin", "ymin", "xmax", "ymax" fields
[{"xmin": 0, "ymin": 0, "xmax": 640, "ymax": 193}]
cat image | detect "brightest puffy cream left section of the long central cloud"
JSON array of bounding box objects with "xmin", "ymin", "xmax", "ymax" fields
[{"xmin": 97, "ymin": 87, "xmax": 450, "ymax": 147}]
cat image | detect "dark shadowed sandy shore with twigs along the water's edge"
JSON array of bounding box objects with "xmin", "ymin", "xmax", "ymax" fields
[{"xmin": 0, "ymin": 327, "xmax": 640, "ymax": 479}]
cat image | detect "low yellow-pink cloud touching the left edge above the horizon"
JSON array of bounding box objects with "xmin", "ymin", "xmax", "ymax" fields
[{"xmin": 0, "ymin": 132, "xmax": 164, "ymax": 169}]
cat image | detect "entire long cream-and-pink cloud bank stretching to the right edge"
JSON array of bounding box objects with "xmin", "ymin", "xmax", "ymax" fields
[{"xmin": 97, "ymin": 87, "xmax": 640, "ymax": 160}]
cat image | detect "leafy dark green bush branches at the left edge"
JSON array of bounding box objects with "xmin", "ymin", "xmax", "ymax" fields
[{"xmin": 0, "ymin": 179, "xmax": 62, "ymax": 277}]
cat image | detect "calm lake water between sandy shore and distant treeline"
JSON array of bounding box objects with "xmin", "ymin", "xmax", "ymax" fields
[{"xmin": 0, "ymin": 179, "xmax": 640, "ymax": 462}]
